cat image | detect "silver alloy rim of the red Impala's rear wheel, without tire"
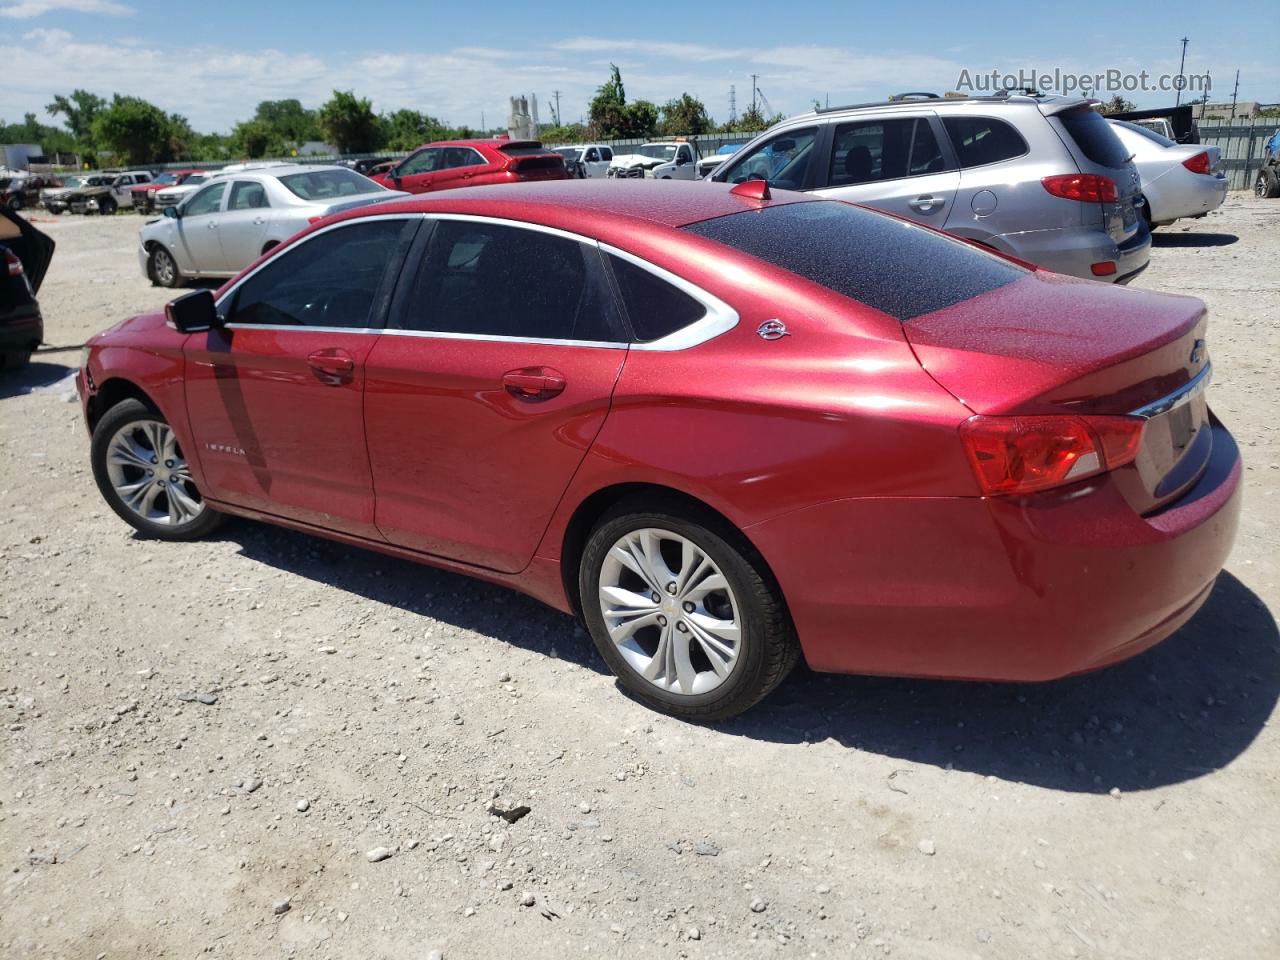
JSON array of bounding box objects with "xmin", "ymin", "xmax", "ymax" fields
[{"xmin": 599, "ymin": 527, "xmax": 742, "ymax": 696}]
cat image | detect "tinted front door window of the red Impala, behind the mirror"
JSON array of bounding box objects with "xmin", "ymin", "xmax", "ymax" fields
[{"xmin": 227, "ymin": 219, "xmax": 412, "ymax": 329}]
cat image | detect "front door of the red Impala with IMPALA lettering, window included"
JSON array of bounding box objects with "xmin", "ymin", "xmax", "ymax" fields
[{"xmin": 184, "ymin": 216, "xmax": 421, "ymax": 540}]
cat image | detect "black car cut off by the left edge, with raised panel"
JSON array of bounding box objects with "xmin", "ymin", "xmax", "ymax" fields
[{"xmin": 0, "ymin": 207, "xmax": 54, "ymax": 370}]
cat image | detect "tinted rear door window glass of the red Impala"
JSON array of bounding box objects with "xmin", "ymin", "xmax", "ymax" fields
[{"xmin": 399, "ymin": 220, "xmax": 621, "ymax": 342}]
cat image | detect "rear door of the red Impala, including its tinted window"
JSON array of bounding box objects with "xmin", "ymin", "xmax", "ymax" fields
[{"xmin": 365, "ymin": 216, "xmax": 627, "ymax": 572}]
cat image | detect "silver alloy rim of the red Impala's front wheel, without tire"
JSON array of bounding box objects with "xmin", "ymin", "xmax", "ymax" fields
[{"xmin": 106, "ymin": 420, "xmax": 205, "ymax": 526}]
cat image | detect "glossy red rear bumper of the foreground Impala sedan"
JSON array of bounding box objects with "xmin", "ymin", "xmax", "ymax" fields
[{"xmin": 746, "ymin": 424, "xmax": 1242, "ymax": 681}]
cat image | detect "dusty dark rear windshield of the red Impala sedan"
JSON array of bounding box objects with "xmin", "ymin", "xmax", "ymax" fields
[{"xmin": 684, "ymin": 200, "xmax": 1027, "ymax": 321}]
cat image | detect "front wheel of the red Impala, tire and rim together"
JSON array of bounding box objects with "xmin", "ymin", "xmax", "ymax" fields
[{"xmin": 90, "ymin": 399, "xmax": 223, "ymax": 540}]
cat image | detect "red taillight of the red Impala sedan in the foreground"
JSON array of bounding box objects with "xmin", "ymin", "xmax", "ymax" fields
[{"xmin": 960, "ymin": 416, "xmax": 1147, "ymax": 497}]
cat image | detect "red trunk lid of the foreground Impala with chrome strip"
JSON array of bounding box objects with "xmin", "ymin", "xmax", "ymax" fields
[{"xmin": 902, "ymin": 273, "xmax": 1212, "ymax": 513}]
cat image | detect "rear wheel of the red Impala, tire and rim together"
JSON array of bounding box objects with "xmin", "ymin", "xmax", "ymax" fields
[{"xmin": 579, "ymin": 500, "xmax": 799, "ymax": 722}]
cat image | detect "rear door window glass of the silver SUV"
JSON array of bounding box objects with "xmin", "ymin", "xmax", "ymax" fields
[{"xmin": 827, "ymin": 116, "xmax": 946, "ymax": 187}]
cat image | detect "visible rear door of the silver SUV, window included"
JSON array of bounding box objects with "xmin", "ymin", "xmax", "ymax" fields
[{"xmin": 814, "ymin": 115, "xmax": 960, "ymax": 229}]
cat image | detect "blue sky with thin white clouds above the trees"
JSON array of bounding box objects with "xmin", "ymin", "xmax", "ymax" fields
[{"xmin": 0, "ymin": 0, "xmax": 1280, "ymax": 132}]
